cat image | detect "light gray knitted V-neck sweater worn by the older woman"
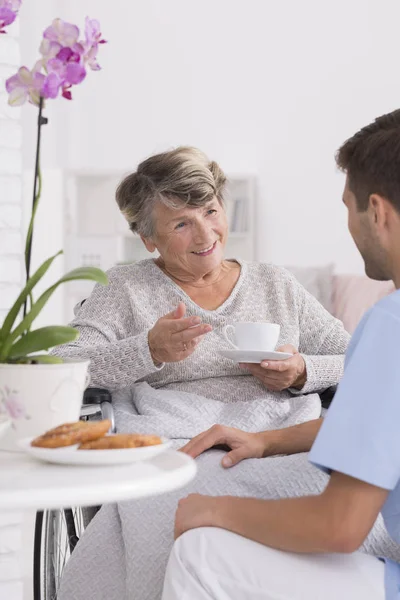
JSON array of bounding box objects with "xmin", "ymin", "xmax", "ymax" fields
[{"xmin": 56, "ymin": 259, "xmax": 349, "ymax": 426}]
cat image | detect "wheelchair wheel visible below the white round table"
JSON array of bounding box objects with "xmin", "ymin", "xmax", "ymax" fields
[{"xmin": 33, "ymin": 507, "xmax": 99, "ymax": 600}]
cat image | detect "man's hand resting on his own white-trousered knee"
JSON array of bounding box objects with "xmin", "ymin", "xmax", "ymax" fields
[{"xmin": 174, "ymin": 494, "xmax": 220, "ymax": 539}]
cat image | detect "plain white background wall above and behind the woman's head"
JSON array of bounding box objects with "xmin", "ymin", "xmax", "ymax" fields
[{"xmin": 17, "ymin": 0, "xmax": 400, "ymax": 286}]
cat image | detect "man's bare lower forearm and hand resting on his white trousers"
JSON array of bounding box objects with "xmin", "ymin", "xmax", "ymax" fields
[{"xmin": 175, "ymin": 473, "xmax": 389, "ymax": 553}]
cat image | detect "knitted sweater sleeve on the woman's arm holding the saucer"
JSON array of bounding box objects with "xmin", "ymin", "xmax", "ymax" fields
[{"xmin": 290, "ymin": 280, "xmax": 350, "ymax": 395}]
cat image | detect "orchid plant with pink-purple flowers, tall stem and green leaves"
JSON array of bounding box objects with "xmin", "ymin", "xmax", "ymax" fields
[{"xmin": 0, "ymin": 11, "xmax": 107, "ymax": 363}]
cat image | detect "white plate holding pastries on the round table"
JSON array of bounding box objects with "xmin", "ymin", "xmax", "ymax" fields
[{"xmin": 18, "ymin": 437, "xmax": 171, "ymax": 465}]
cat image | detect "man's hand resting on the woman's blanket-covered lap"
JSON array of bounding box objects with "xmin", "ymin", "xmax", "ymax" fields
[{"xmin": 181, "ymin": 425, "xmax": 273, "ymax": 467}]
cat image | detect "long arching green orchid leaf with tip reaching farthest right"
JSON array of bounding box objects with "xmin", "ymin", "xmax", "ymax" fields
[{"xmin": 0, "ymin": 267, "xmax": 108, "ymax": 362}]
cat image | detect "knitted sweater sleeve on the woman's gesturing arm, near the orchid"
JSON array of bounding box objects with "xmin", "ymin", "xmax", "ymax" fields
[{"xmin": 53, "ymin": 273, "xmax": 163, "ymax": 391}]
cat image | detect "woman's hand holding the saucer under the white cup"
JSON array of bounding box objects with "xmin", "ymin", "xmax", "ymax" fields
[{"xmin": 240, "ymin": 344, "xmax": 307, "ymax": 392}]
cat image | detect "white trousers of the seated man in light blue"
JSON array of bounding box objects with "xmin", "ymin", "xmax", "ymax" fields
[{"xmin": 162, "ymin": 527, "xmax": 385, "ymax": 600}]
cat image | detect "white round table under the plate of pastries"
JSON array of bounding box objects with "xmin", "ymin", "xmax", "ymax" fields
[{"xmin": 0, "ymin": 450, "xmax": 196, "ymax": 510}]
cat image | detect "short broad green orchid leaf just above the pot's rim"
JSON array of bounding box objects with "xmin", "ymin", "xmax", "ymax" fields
[{"xmin": 8, "ymin": 325, "xmax": 79, "ymax": 359}]
